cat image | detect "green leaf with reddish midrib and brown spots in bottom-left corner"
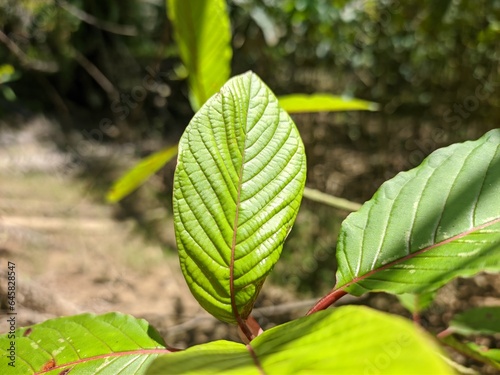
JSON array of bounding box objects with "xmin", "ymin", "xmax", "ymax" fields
[{"xmin": 0, "ymin": 313, "xmax": 169, "ymax": 375}]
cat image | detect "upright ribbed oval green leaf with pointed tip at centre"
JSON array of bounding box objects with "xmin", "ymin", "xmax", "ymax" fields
[{"xmin": 174, "ymin": 72, "xmax": 306, "ymax": 323}]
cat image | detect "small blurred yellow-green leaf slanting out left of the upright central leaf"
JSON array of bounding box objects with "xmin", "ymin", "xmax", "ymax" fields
[{"xmin": 106, "ymin": 145, "xmax": 177, "ymax": 203}]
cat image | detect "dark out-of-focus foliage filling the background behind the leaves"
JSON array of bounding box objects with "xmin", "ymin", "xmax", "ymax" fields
[{"xmin": 0, "ymin": 0, "xmax": 500, "ymax": 291}]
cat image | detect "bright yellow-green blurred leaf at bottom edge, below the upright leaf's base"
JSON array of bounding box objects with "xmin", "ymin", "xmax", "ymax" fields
[{"xmin": 147, "ymin": 306, "xmax": 453, "ymax": 375}]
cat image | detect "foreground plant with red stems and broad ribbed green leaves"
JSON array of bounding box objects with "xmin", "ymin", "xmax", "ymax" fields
[{"xmin": 0, "ymin": 72, "xmax": 500, "ymax": 375}]
